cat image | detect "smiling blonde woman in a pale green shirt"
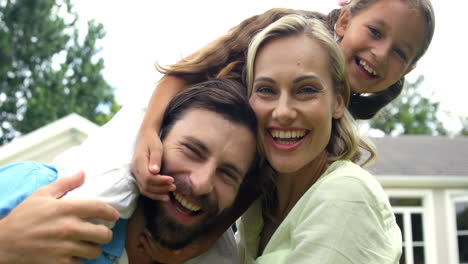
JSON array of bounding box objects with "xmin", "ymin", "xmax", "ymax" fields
[{"xmin": 237, "ymin": 15, "xmax": 402, "ymax": 264}]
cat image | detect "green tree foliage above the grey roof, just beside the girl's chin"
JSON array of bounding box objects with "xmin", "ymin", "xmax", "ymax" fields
[{"xmin": 370, "ymin": 76, "xmax": 447, "ymax": 135}]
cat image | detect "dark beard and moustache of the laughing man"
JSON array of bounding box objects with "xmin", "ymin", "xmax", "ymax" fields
[{"xmin": 142, "ymin": 177, "xmax": 226, "ymax": 249}]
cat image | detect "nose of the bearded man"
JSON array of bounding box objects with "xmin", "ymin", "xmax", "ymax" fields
[{"xmin": 190, "ymin": 162, "xmax": 216, "ymax": 195}]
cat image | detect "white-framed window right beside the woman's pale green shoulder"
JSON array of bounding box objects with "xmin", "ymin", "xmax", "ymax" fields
[{"xmin": 390, "ymin": 198, "xmax": 427, "ymax": 264}]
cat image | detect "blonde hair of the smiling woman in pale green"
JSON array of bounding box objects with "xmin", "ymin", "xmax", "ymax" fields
[{"xmin": 246, "ymin": 14, "xmax": 376, "ymax": 165}]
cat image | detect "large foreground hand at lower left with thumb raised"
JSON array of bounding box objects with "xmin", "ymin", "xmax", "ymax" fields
[{"xmin": 0, "ymin": 172, "xmax": 119, "ymax": 263}]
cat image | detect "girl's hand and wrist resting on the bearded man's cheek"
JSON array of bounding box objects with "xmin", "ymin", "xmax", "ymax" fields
[{"xmin": 131, "ymin": 128, "xmax": 175, "ymax": 201}]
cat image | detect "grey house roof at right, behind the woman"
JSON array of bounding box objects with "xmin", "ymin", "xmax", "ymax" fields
[{"xmin": 368, "ymin": 136, "xmax": 468, "ymax": 177}]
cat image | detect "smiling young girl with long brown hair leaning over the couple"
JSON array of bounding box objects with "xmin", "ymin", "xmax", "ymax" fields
[{"xmin": 132, "ymin": 0, "xmax": 435, "ymax": 199}]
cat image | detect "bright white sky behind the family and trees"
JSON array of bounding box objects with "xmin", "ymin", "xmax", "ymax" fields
[{"xmin": 74, "ymin": 0, "xmax": 468, "ymax": 130}]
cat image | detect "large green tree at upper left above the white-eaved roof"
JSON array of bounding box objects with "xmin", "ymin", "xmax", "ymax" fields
[{"xmin": 0, "ymin": 0, "xmax": 119, "ymax": 145}]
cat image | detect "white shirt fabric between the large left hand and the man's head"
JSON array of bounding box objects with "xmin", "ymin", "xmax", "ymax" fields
[{"xmin": 53, "ymin": 106, "xmax": 146, "ymax": 227}]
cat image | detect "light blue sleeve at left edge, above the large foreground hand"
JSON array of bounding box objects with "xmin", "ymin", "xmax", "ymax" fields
[{"xmin": 0, "ymin": 161, "xmax": 57, "ymax": 218}]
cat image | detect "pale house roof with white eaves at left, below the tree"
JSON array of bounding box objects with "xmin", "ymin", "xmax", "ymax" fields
[{"xmin": 0, "ymin": 114, "xmax": 99, "ymax": 166}]
